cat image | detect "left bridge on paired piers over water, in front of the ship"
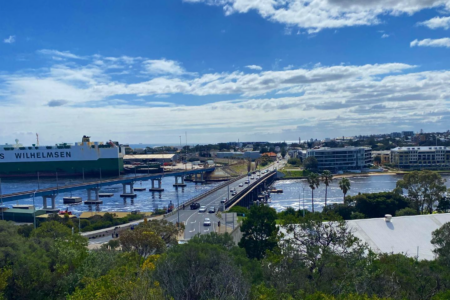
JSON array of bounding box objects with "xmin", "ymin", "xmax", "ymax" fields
[{"xmin": 0, "ymin": 167, "xmax": 215, "ymax": 210}]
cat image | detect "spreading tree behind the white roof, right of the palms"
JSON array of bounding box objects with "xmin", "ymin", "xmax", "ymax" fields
[{"xmin": 397, "ymin": 171, "xmax": 447, "ymax": 214}]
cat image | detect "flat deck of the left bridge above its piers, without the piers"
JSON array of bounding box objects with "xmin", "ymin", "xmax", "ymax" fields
[{"xmin": 1, "ymin": 167, "xmax": 215, "ymax": 202}]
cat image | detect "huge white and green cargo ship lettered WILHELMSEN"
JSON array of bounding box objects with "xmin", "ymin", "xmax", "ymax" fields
[{"xmin": 0, "ymin": 136, "xmax": 125, "ymax": 177}]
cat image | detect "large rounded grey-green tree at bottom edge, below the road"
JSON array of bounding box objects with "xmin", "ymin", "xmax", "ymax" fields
[{"xmin": 153, "ymin": 241, "xmax": 250, "ymax": 300}]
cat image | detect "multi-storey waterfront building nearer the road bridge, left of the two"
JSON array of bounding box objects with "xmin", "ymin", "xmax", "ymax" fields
[{"xmin": 307, "ymin": 147, "xmax": 373, "ymax": 172}]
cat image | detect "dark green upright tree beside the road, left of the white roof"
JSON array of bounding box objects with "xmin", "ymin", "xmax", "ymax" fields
[{"xmin": 239, "ymin": 205, "xmax": 278, "ymax": 260}]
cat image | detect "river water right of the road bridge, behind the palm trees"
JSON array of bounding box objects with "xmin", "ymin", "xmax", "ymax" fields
[{"xmin": 270, "ymin": 175, "xmax": 450, "ymax": 211}]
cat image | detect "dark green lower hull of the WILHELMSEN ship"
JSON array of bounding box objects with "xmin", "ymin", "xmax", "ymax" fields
[{"xmin": 0, "ymin": 158, "xmax": 123, "ymax": 177}]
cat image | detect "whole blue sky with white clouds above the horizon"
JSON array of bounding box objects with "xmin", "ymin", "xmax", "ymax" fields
[{"xmin": 0, "ymin": 0, "xmax": 450, "ymax": 145}]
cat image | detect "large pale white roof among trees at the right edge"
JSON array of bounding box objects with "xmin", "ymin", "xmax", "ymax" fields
[{"xmin": 347, "ymin": 214, "xmax": 450, "ymax": 260}]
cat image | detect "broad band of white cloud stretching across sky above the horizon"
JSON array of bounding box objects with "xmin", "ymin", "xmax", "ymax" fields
[{"xmin": 0, "ymin": 49, "xmax": 450, "ymax": 144}]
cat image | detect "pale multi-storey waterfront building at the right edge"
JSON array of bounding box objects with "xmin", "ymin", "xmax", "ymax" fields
[{"xmin": 391, "ymin": 146, "xmax": 450, "ymax": 170}]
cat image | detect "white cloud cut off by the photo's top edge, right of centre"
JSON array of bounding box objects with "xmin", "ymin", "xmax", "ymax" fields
[{"xmin": 184, "ymin": 0, "xmax": 450, "ymax": 33}]
